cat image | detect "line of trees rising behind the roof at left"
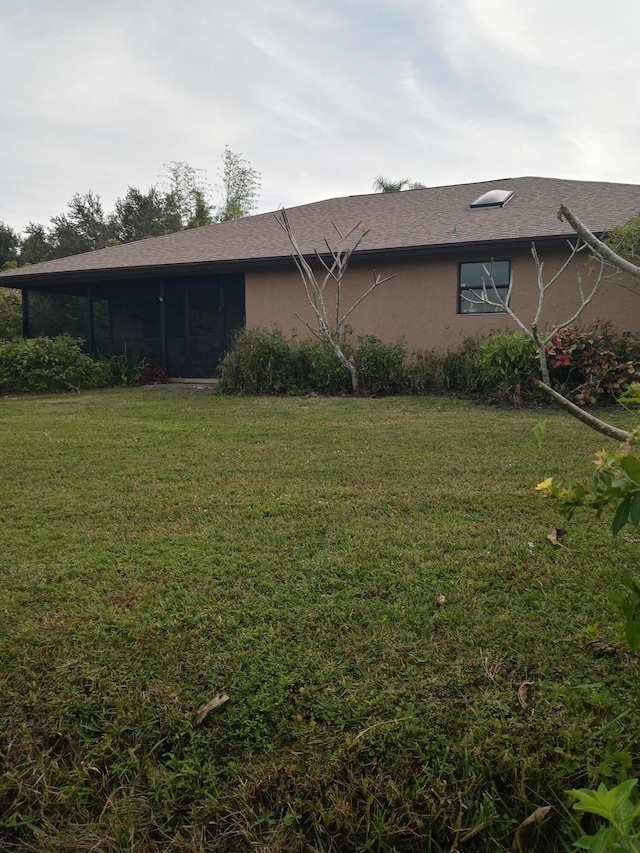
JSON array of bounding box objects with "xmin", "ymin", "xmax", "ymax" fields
[{"xmin": 0, "ymin": 147, "xmax": 261, "ymax": 269}]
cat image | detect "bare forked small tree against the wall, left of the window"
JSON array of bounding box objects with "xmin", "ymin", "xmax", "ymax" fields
[{"xmin": 276, "ymin": 208, "xmax": 394, "ymax": 395}]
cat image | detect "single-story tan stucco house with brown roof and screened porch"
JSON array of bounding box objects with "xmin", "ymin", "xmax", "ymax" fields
[{"xmin": 0, "ymin": 177, "xmax": 640, "ymax": 377}]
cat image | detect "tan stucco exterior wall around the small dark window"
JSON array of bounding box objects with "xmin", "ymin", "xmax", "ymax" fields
[{"xmin": 246, "ymin": 246, "xmax": 640, "ymax": 350}]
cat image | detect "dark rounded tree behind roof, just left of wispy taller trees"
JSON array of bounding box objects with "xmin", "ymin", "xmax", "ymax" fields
[{"xmin": 110, "ymin": 187, "xmax": 182, "ymax": 243}]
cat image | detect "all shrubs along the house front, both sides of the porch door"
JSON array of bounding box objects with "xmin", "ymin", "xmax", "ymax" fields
[{"xmin": 5, "ymin": 323, "xmax": 640, "ymax": 405}]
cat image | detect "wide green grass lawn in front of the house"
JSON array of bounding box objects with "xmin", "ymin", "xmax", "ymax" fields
[{"xmin": 0, "ymin": 388, "xmax": 640, "ymax": 853}]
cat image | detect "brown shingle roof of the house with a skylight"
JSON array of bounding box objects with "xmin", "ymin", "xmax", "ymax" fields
[{"xmin": 0, "ymin": 177, "xmax": 640, "ymax": 285}]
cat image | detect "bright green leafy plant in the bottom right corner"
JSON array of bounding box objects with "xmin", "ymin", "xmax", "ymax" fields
[{"xmin": 569, "ymin": 779, "xmax": 640, "ymax": 853}]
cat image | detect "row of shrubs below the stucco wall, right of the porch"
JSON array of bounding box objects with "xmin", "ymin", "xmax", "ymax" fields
[{"xmin": 221, "ymin": 323, "xmax": 640, "ymax": 404}]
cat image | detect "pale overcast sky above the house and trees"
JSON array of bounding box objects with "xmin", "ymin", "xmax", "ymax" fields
[{"xmin": 0, "ymin": 0, "xmax": 640, "ymax": 230}]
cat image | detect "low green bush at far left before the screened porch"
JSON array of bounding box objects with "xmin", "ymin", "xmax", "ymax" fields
[{"xmin": 0, "ymin": 335, "xmax": 101, "ymax": 392}]
